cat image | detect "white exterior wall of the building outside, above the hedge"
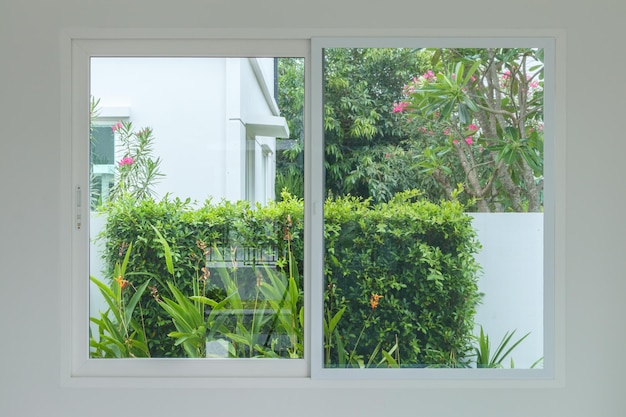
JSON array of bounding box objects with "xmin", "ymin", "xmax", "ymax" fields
[{"xmin": 91, "ymin": 58, "xmax": 276, "ymax": 203}]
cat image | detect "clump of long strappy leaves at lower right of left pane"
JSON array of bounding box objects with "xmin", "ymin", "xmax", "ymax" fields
[{"xmin": 155, "ymin": 223, "xmax": 304, "ymax": 358}]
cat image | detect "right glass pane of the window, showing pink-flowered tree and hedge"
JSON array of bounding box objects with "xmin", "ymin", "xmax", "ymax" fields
[{"xmin": 323, "ymin": 47, "xmax": 544, "ymax": 369}]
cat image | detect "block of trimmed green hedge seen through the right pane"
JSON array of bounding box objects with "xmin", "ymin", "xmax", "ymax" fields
[{"xmin": 325, "ymin": 192, "xmax": 479, "ymax": 366}]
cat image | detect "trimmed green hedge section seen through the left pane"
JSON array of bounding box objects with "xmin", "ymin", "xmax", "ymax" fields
[{"xmin": 100, "ymin": 193, "xmax": 304, "ymax": 357}]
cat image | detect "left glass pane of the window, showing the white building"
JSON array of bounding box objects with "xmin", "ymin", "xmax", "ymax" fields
[{"xmin": 90, "ymin": 57, "xmax": 304, "ymax": 358}]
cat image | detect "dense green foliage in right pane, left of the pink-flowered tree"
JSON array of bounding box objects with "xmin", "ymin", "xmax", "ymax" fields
[{"xmin": 324, "ymin": 48, "xmax": 429, "ymax": 201}]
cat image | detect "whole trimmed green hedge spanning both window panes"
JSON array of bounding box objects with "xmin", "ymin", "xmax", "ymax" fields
[{"xmin": 96, "ymin": 188, "xmax": 479, "ymax": 365}]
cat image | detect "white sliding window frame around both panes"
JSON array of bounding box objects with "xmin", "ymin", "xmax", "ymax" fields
[{"xmin": 61, "ymin": 30, "xmax": 565, "ymax": 388}]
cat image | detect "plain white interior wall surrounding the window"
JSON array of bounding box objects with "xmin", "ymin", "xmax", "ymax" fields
[{"xmin": 0, "ymin": 0, "xmax": 626, "ymax": 417}]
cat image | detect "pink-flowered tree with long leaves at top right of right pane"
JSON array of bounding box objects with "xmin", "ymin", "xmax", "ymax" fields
[{"xmin": 394, "ymin": 48, "xmax": 543, "ymax": 212}]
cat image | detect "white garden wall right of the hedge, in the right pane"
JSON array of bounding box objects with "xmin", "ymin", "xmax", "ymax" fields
[{"xmin": 472, "ymin": 213, "xmax": 544, "ymax": 368}]
